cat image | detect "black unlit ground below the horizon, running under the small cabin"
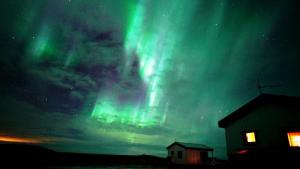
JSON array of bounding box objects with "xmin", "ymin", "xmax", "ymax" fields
[{"xmin": 0, "ymin": 144, "xmax": 230, "ymax": 169}]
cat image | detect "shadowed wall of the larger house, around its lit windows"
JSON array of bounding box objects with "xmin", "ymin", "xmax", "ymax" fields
[{"xmin": 225, "ymin": 104, "xmax": 300, "ymax": 155}]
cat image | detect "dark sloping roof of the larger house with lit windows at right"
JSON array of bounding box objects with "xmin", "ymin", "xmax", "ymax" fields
[{"xmin": 218, "ymin": 94, "xmax": 300, "ymax": 128}]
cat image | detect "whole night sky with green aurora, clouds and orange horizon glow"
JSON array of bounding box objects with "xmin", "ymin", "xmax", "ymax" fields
[{"xmin": 0, "ymin": 0, "xmax": 300, "ymax": 158}]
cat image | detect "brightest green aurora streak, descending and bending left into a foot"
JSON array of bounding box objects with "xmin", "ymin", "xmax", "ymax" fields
[{"xmin": 92, "ymin": 0, "xmax": 196, "ymax": 127}]
